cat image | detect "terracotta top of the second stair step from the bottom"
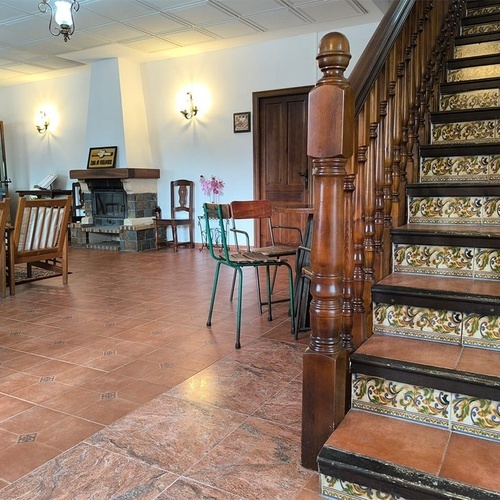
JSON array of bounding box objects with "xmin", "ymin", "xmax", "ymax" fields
[{"xmin": 352, "ymin": 333, "xmax": 500, "ymax": 378}]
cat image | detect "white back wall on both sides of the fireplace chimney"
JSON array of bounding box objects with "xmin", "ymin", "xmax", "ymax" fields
[{"xmin": 0, "ymin": 23, "xmax": 377, "ymax": 237}]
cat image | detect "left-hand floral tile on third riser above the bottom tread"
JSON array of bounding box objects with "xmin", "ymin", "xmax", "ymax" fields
[{"xmin": 393, "ymin": 244, "xmax": 474, "ymax": 277}]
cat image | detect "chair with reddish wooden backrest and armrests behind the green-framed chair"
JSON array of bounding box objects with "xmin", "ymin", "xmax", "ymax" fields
[{"xmin": 231, "ymin": 200, "xmax": 302, "ymax": 314}]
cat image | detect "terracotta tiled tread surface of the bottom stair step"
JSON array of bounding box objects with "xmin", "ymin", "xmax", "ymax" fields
[{"xmin": 319, "ymin": 409, "xmax": 500, "ymax": 498}]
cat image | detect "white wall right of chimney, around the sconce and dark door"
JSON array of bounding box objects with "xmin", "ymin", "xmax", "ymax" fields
[{"xmin": 143, "ymin": 23, "xmax": 377, "ymax": 229}]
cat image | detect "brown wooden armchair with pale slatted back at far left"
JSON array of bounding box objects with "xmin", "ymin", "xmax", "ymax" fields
[{"xmin": 8, "ymin": 196, "xmax": 72, "ymax": 295}]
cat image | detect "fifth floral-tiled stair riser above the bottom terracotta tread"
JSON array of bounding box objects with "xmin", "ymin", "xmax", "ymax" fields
[{"xmin": 420, "ymin": 155, "xmax": 500, "ymax": 182}]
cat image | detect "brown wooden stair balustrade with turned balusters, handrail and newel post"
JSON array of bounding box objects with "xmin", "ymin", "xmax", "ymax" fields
[{"xmin": 302, "ymin": 0, "xmax": 465, "ymax": 469}]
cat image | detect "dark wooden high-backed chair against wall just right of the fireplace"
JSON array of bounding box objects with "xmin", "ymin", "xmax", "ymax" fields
[{"xmin": 153, "ymin": 179, "xmax": 194, "ymax": 252}]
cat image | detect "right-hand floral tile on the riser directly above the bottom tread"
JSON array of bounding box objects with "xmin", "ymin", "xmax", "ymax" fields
[{"xmin": 451, "ymin": 394, "xmax": 500, "ymax": 441}]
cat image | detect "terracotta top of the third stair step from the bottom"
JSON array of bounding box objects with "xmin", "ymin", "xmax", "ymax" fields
[{"xmin": 377, "ymin": 273, "xmax": 500, "ymax": 299}]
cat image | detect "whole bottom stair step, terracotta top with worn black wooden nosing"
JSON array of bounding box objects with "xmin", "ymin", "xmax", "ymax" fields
[{"xmin": 318, "ymin": 409, "xmax": 500, "ymax": 500}]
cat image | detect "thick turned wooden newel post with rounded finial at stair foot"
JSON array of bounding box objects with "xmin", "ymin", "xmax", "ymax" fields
[{"xmin": 302, "ymin": 33, "xmax": 354, "ymax": 469}]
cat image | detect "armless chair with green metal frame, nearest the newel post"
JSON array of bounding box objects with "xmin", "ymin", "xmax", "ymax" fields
[{"xmin": 203, "ymin": 203, "xmax": 295, "ymax": 349}]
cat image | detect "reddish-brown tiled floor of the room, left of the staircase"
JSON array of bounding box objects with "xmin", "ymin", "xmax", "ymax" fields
[{"xmin": 0, "ymin": 249, "xmax": 320, "ymax": 500}]
